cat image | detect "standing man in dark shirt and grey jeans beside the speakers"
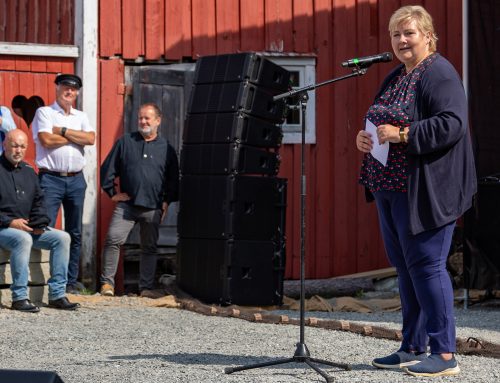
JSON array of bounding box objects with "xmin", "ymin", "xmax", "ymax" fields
[{"xmin": 101, "ymin": 103, "xmax": 179, "ymax": 296}]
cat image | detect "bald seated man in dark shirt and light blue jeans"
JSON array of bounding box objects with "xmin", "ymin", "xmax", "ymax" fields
[{"xmin": 0, "ymin": 129, "xmax": 79, "ymax": 312}]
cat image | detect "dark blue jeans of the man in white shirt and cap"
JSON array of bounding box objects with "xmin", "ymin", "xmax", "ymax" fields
[{"xmin": 39, "ymin": 173, "xmax": 87, "ymax": 285}]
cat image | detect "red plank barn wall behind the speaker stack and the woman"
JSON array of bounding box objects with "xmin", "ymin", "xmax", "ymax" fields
[{"xmin": 99, "ymin": 0, "xmax": 462, "ymax": 278}]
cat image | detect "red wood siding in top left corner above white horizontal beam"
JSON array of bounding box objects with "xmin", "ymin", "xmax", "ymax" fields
[{"xmin": 0, "ymin": 0, "xmax": 75, "ymax": 45}]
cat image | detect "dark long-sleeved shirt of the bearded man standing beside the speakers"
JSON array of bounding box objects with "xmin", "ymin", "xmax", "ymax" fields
[{"xmin": 101, "ymin": 132, "xmax": 179, "ymax": 209}]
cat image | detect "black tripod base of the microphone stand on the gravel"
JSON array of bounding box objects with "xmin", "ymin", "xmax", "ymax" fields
[{"xmin": 224, "ymin": 343, "xmax": 351, "ymax": 382}]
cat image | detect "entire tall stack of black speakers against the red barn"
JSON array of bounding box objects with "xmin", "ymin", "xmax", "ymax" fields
[{"xmin": 177, "ymin": 53, "xmax": 290, "ymax": 305}]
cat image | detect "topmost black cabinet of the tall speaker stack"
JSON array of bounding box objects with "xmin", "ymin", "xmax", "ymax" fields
[{"xmin": 194, "ymin": 53, "xmax": 290, "ymax": 93}]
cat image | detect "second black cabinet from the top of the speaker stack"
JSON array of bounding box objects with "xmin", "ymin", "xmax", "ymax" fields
[{"xmin": 188, "ymin": 82, "xmax": 285, "ymax": 123}]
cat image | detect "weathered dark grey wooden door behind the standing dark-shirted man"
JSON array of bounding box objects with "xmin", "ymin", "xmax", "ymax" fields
[{"xmin": 123, "ymin": 64, "xmax": 195, "ymax": 292}]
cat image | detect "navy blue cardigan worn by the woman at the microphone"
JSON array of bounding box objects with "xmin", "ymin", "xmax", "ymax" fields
[{"xmin": 368, "ymin": 53, "xmax": 477, "ymax": 234}]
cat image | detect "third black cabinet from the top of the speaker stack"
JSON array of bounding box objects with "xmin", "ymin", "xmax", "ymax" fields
[{"xmin": 183, "ymin": 112, "xmax": 283, "ymax": 148}]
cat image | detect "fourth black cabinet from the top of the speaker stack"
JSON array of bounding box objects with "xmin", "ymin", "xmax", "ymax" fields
[{"xmin": 181, "ymin": 143, "xmax": 279, "ymax": 175}]
